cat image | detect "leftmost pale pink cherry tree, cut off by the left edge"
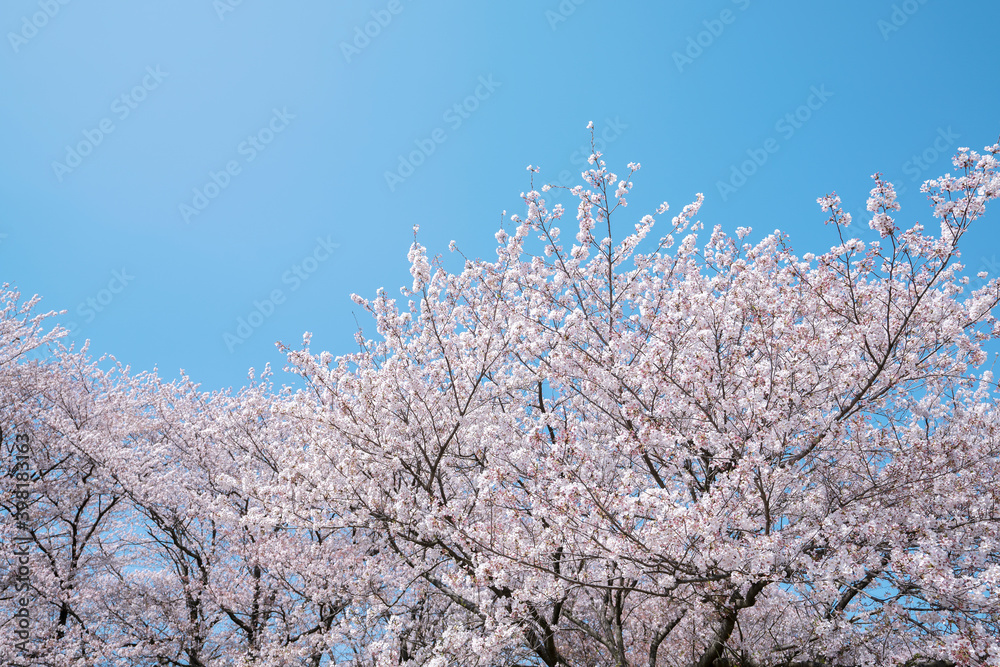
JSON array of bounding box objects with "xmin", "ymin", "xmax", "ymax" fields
[{"xmin": 0, "ymin": 286, "xmax": 138, "ymax": 664}]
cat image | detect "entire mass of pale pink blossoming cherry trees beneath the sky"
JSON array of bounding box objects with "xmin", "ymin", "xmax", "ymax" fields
[{"xmin": 0, "ymin": 133, "xmax": 1000, "ymax": 667}]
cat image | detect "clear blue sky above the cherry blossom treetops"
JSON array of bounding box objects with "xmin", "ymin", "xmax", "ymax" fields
[{"xmin": 0, "ymin": 0, "xmax": 1000, "ymax": 389}]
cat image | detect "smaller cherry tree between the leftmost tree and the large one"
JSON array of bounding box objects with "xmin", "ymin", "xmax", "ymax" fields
[{"xmin": 50, "ymin": 373, "xmax": 368, "ymax": 667}]
